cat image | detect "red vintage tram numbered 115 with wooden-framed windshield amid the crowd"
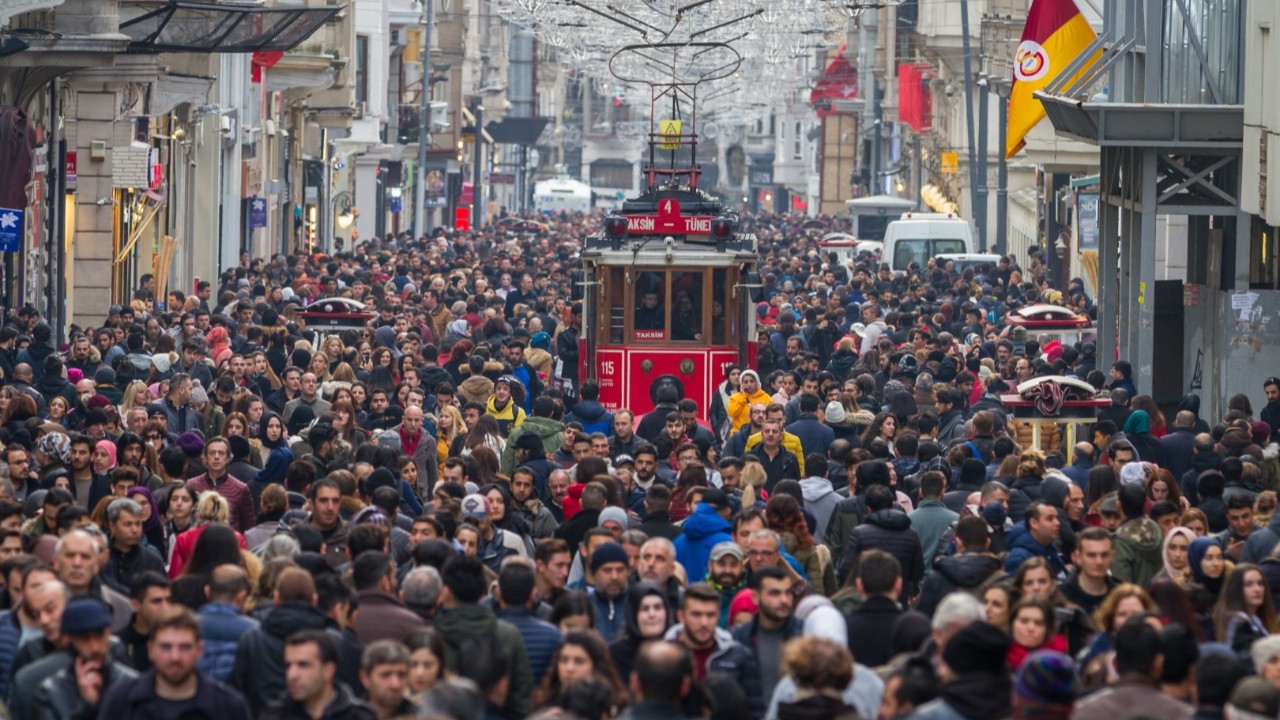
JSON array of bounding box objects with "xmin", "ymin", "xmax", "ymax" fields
[{"xmin": 580, "ymin": 188, "xmax": 758, "ymax": 420}]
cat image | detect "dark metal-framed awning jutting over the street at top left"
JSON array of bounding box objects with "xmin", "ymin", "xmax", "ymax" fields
[{"xmin": 120, "ymin": 1, "xmax": 346, "ymax": 53}]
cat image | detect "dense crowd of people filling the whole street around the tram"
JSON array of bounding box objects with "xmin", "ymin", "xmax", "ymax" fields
[{"xmin": 0, "ymin": 210, "xmax": 1280, "ymax": 720}]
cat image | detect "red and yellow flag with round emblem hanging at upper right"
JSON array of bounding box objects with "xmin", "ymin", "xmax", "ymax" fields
[{"xmin": 1005, "ymin": 0, "xmax": 1097, "ymax": 158}]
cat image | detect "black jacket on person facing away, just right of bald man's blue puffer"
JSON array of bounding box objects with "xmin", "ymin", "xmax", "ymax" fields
[{"xmin": 230, "ymin": 601, "xmax": 325, "ymax": 707}]
